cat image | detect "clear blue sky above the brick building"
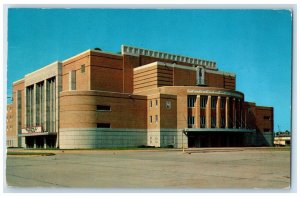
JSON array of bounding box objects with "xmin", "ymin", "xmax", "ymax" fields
[{"xmin": 7, "ymin": 9, "xmax": 292, "ymax": 131}]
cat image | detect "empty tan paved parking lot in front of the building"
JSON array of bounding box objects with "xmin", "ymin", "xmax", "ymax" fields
[{"xmin": 6, "ymin": 148, "xmax": 290, "ymax": 189}]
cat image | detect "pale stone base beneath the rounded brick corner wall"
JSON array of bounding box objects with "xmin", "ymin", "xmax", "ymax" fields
[{"xmin": 59, "ymin": 128, "xmax": 147, "ymax": 149}]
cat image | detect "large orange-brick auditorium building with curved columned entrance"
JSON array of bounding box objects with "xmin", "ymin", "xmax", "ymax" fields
[{"xmin": 7, "ymin": 45, "xmax": 273, "ymax": 149}]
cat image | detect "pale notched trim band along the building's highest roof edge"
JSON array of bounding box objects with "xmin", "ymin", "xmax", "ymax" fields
[{"xmin": 121, "ymin": 45, "xmax": 217, "ymax": 70}]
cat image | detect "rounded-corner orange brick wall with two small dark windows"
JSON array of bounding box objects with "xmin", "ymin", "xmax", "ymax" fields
[{"xmin": 60, "ymin": 91, "xmax": 147, "ymax": 129}]
